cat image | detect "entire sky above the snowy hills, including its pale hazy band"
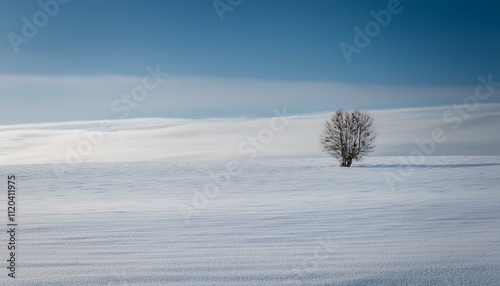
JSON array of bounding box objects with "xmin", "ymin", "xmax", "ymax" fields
[{"xmin": 0, "ymin": 0, "xmax": 500, "ymax": 161}]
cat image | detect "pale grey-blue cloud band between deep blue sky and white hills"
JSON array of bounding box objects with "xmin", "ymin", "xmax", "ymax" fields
[{"xmin": 0, "ymin": 73, "xmax": 492, "ymax": 124}]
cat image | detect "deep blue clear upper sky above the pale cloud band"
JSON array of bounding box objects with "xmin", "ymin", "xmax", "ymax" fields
[{"xmin": 0, "ymin": 0, "xmax": 500, "ymax": 85}]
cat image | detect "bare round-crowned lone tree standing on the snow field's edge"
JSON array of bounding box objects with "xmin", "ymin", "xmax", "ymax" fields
[{"xmin": 320, "ymin": 109, "xmax": 377, "ymax": 167}]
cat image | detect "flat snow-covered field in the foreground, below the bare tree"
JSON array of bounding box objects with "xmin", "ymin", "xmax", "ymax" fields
[{"xmin": 0, "ymin": 157, "xmax": 500, "ymax": 285}]
